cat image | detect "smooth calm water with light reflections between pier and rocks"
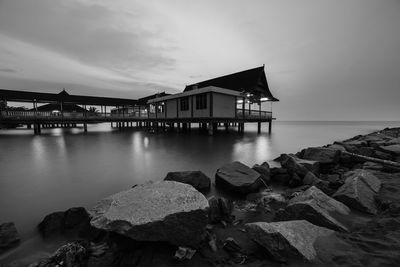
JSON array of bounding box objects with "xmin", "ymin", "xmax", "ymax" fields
[{"xmin": 0, "ymin": 122, "xmax": 400, "ymax": 264}]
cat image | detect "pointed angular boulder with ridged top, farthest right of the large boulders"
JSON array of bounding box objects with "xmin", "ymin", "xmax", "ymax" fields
[{"xmin": 333, "ymin": 170, "xmax": 381, "ymax": 214}]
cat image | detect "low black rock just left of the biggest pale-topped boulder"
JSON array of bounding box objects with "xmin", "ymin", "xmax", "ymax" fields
[{"xmin": 38, "ymin": 207, "xmax": 91, "ymax": 238}]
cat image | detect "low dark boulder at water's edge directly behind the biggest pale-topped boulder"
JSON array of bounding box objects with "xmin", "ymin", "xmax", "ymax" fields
[{"xmin": 164, "ymin": 171, "xmax": 211, "ymax": 191}]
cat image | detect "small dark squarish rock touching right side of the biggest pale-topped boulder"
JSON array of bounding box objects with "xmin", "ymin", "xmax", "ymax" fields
[{"xmin": 208, "ymin": 196, "xmax": 233, "ymax": 223}]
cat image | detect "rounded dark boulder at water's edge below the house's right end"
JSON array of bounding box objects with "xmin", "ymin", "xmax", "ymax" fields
[{"xmin": 215, "ymin": 161, "xmax": 264, "ymax": 194}]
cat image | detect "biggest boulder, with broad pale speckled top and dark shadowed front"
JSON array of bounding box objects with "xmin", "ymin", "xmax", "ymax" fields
[{"xmin": 90, "ymin": 181, "xmax": 209, "ymax": 246}]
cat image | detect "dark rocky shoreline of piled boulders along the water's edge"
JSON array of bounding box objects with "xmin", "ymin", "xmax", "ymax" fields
[{"xmin": 0, "ymin": 128, "xmax": 400, "ymax": 266}]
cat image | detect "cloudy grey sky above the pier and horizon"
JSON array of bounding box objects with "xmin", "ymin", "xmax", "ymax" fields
[{"xmin": 0, "ymin": 0, "xmax": 400, "ymax": 121}]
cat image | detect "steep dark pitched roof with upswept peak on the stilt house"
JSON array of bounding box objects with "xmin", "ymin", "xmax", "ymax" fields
[{"xmin": 184, "ymin": 66, "xmax": 279, "ymax": 101}]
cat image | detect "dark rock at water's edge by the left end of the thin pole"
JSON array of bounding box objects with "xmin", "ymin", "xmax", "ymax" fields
[{"xmin": 300, "ymin": 147, "xmax": 341, "ymax": 170}]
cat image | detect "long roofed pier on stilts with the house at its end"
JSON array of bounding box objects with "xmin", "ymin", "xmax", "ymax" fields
[{"xmin": 0, "ymin": 66, "xmax": 279, "ymax": 135}]
